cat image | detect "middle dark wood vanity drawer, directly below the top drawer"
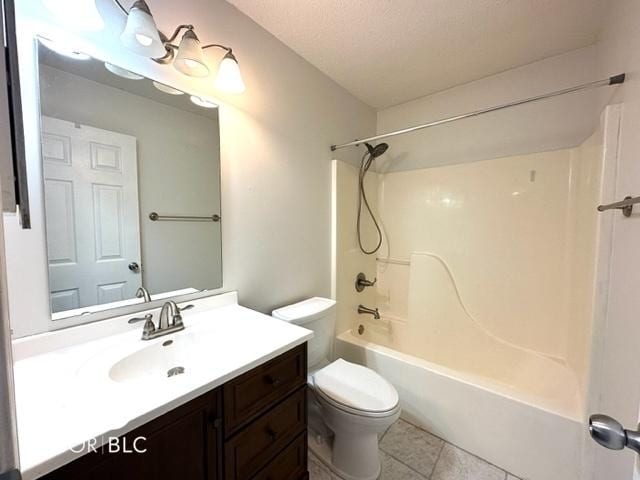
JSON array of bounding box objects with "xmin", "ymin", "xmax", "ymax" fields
[{"xmin": 225, "ymin": 385, "xmax": 307, "ymax": 480}]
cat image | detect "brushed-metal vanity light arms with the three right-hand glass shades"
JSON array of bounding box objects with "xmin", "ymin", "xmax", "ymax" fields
[{"xmin": 113, "ymin": 0, "xmax": 245, "ymax": 93}]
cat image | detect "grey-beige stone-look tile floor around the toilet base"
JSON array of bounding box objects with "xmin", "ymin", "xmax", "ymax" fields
[{"xmin": 309, "ymin": 420, "xmax": 519, "ymax": 480}]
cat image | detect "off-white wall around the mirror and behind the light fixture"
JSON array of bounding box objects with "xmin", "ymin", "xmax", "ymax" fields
[{"xmin": 3, "ymin": 0, "xmax": 376, "ymax": 338}]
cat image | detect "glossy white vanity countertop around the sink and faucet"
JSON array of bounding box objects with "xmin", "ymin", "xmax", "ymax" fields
[{"xmin": 9, "ymin": 293, "xmax": 313, "ymax": 480}]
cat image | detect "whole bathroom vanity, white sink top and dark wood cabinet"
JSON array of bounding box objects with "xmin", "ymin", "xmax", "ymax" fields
[{"xmin": 14, "ymin": 293, "xmax": 311, "ymax": 480}]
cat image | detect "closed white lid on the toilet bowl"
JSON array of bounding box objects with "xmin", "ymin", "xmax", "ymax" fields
[{"xmin": 313, "ymin": 358, "xmax": 398, "ymax": 412}]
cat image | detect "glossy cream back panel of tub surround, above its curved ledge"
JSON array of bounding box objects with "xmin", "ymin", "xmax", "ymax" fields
[{"xmin": 378, "ymin": 149, "xmax": 598, "ymax": 365}]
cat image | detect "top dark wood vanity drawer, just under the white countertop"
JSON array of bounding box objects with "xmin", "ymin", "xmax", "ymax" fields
[{"xmin": 224, "ymin": 343, "xmax": 307, "ymax": 437}]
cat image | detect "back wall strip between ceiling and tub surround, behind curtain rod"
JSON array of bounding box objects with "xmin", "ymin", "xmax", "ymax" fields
[{"xmin": 376, "ymin": 46, "xmax": 612, "ymax": 172}]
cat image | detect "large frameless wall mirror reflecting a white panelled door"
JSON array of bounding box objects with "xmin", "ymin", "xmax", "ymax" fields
[{"xmin": 37, "ymin": 40, "xmax": 222, "ymax": 321}]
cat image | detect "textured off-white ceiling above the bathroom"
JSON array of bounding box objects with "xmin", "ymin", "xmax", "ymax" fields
[{"xmin": 227, "ymin": 0, "xmax": 607, "ymax": 108}]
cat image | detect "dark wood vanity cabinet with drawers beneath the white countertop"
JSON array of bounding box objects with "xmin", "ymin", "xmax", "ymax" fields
[{"xmin": 42, "ymin": 344, "xmax": 308, "ymax": 480}]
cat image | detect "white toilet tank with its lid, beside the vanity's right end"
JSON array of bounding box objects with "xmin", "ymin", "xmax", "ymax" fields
[{"xmin": 271, "ymin": 297, "xmax": 336, "ymax": 371}]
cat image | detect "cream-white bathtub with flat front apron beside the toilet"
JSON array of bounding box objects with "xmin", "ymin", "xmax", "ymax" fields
[{"xmin": 335, "ymin": 328, "xmax": 586, "ymax": 480}]
